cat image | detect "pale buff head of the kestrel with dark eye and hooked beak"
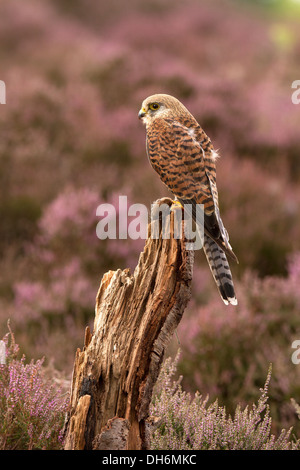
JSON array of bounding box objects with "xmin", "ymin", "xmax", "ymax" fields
[{"xmin": 138, "ymin": 94, "xmax": 187, "ymax": 125}]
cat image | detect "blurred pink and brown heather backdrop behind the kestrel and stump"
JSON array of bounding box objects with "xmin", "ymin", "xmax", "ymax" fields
[{"xmin": 0, "ymin": 0, "xmax": 300, "ymax": 437}]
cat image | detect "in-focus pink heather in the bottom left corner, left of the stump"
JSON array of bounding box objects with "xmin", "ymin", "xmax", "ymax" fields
[{"xmin": 0, "ymin": 324, "xmax": 68, "ymax": 450}]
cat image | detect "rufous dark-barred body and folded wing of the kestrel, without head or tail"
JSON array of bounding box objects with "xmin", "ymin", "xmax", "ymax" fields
[{"xmin": 147, "ymin": 119, "xmax": 236, "ymax": 260}]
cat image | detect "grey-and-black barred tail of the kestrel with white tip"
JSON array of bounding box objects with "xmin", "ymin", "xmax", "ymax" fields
[{"xmin": 203, "ymin": 234, "xmax": 237, "ymax": 305}]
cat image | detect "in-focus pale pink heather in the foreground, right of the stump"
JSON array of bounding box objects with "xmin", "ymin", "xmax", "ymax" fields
[{"xmin": 150, "ymin": 352, "xmax": 300, "ymax": 450}]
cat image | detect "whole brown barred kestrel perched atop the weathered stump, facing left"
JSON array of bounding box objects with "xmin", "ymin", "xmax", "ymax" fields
[{"xmin": 139, "ymin": 94, "xmax": 237, "ymax": 305}]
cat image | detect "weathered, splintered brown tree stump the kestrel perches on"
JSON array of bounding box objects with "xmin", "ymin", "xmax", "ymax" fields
[{"xmin": 65, "ymin": 199, "xmax": 194, "ymax": 450}]
